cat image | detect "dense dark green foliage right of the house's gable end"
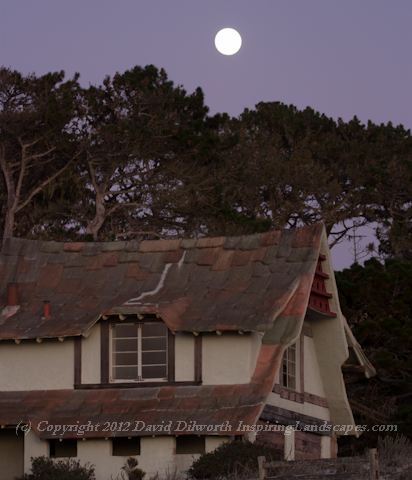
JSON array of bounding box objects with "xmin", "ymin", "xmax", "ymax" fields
[{"xmin": 336, "ymin": 259, "xmax": 412, "ymax": 435}]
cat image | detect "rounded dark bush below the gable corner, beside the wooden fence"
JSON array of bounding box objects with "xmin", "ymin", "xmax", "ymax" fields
[{"xmin": 188, "ymin": 441, "xmax": 279, "ymax": 480}]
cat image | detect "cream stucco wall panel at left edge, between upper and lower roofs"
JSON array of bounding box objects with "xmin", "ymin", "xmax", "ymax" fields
[{"xmin": 0, "ymin": 339, "xmax": 74, "ymax": 391}]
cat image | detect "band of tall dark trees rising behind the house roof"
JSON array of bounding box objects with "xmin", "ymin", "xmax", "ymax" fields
[{"xmin": 0, "ymin": 65, "xmax": 412, "ymax": 258}]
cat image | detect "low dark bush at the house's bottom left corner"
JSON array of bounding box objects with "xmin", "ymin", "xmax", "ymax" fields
[{"xmin": 19, "ymin": 457, "xmax": 96, "ymax": 480}]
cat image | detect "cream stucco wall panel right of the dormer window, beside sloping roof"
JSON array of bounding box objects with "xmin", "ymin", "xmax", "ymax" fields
[{"xmin": 202, "ymin": 333, "xmax": 261, "ymax": 385}]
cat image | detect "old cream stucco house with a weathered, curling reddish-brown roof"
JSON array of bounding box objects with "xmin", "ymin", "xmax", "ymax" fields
[{"xmin": 0, "ymin": 225, "xmax": 374, "ymax": 480}]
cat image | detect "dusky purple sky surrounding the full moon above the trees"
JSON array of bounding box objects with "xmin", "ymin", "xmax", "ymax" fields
[{"xmin": 0, "ymin": 0, "xmax": 412, "ymax": 269}]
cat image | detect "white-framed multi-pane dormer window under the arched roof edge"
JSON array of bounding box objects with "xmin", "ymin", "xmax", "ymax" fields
[{"xmin": 112, "ymin": 322, "xmax": 168, "ymax": 382}]
